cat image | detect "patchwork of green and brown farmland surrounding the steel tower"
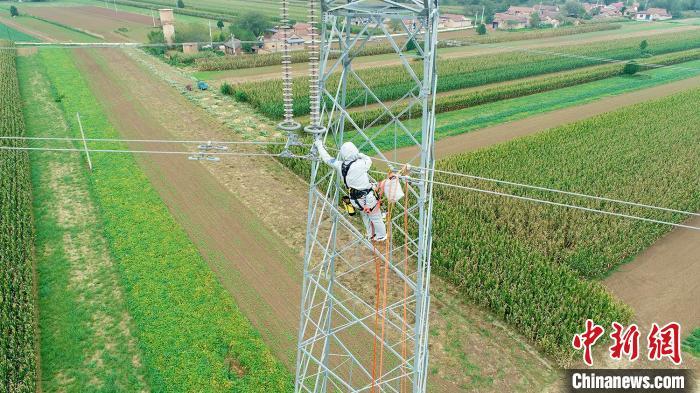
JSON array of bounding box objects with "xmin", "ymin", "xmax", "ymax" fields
[{"xmin": 0, "ymin": 0, "xmax": 700, "ymax": 393}]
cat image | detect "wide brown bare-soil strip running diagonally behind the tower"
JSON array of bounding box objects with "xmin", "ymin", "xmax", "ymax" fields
[{"xmin": 65, "ymin": 50, "xmax": 556, "ymax": 392}]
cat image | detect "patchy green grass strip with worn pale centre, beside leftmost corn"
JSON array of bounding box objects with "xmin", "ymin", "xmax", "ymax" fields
[{"xmin": 18, "ymin": 50, "xmax": 149, "ymax": 392}]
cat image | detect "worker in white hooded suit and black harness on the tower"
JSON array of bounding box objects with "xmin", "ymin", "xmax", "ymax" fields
[{"xmin": 314, "ymin": 140, "xmax": 386, "ymax": 242}]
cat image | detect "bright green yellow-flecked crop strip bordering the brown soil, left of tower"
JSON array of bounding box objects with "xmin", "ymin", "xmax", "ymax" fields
[{"xmin": 40, "ymin": 50, "xmax": 292, "ymax": 392}]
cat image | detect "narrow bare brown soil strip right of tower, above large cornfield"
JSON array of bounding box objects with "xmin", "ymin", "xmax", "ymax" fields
[{"xmin": 388, "ymin": 72, "xmax": 700, "ymax": 162}]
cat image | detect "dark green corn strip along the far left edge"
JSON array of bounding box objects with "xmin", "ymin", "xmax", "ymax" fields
[{"xmin": 0, "ymin": 40, "xmax": 37, "ymax": 393}]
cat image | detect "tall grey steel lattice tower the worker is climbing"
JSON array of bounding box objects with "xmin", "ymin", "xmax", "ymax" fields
[{"xmin": 296, "ymin": 0, "xmax": 438, "ymax": 392}]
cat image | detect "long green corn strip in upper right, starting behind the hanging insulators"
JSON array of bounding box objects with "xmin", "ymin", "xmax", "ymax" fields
[{"xmin": 234, "ymin": 31, "xmax": 700, "ymax": 119}]
